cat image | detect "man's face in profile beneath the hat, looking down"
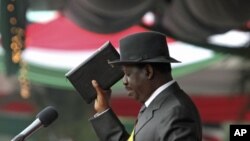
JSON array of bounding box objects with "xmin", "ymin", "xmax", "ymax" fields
[{"xmin": 122, "ymin": 65, "xmax": 151, "ymax": 103}]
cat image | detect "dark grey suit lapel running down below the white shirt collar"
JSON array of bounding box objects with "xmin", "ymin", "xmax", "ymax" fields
[{"xmin": 135, "ymin": 82, "xmax": 179, "ymax": 135}]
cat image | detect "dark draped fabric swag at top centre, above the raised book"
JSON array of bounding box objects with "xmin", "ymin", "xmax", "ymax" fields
[{"xmin": 61, "ymin": 0, "xmax": 153, "ymax": 33}]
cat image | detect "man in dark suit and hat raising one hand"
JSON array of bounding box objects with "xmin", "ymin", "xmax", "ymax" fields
[{"xmin": 90, "ymin": 32, "xmax": 202, "ymax": 141}]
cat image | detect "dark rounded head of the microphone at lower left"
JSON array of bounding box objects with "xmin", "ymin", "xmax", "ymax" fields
[{"xmin": 36, "ymin": 106, "xmax": 58, "ymax": 127}]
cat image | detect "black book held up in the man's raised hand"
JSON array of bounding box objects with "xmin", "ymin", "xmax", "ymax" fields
[{"xmin": 65, "ymin": 41, "xmax": 123, "ymax": 104}]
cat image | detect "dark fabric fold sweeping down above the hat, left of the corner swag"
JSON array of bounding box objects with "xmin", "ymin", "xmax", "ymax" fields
[{"xmin": 161, "ymin": 0, "xmax": 227, "ymax": 42}]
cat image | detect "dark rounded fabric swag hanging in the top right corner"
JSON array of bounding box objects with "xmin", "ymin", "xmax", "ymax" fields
[{"xmin": 187, "ymin": 0, "xmax": 250, "ymax": 29}]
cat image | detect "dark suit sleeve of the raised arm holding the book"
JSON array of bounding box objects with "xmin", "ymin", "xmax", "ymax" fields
[{"xmin": 90, "ymin": 109, "xmax": 129, "ymax": 141}]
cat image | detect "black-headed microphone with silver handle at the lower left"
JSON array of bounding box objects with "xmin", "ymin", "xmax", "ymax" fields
[{"xmin": 11, "ymin": 106, "xmax": 58, "ymax": 141}]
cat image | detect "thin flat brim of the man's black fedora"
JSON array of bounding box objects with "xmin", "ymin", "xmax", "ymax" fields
[{"xmin": 108, "ymin": 57, "xmax": 181, "ymax": 65}]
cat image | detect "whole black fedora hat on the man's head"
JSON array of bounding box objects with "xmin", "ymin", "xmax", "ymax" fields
[{"xmin": 109, "ymin": 31, "xmax": 179, "ymax": 64}]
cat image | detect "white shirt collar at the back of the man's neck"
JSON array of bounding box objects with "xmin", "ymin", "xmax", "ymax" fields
[{"xmin": 144, "ymin": 80, "xmax": 175, "ymax": 107}]
